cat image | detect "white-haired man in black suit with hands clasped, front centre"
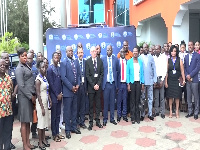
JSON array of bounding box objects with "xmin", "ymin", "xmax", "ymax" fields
[{"xmin": 85, "ymin": 46, "xmax": 103, "ymax": 130}]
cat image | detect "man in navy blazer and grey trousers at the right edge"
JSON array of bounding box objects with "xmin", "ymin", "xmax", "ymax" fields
[{"xmin": 184, "ymin": 41, "xmax": 200, "ymax": 120}]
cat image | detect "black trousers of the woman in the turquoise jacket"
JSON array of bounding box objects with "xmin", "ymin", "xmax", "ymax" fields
[{"xmin": 130, "ymin": 81, "xmax": 142, "ymax": 121}]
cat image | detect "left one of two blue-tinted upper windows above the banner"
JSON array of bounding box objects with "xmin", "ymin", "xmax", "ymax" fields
[{"xmin": 79, "ymin": 0, "xmax": 105, "ymax": 24}]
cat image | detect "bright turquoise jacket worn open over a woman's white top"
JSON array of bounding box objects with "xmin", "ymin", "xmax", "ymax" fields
[{"xmin": 126, "ymin": 58, "xmax": 144, "ymax": 84}]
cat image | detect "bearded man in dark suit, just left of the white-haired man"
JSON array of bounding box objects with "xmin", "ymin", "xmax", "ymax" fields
[{"xmin": 76, "ymin": 47, "xmax": 87, "ymax": 129}]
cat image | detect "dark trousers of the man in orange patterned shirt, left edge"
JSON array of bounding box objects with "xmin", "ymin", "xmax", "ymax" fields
[{"xmin": 0, "ymin": 115, "xmax": 13, "ymax": 150}]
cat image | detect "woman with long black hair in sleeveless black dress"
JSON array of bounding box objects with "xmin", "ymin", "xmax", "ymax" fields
[{"xmin": 165, "ymin": 45, "xmax": 185, "ymax": 118}]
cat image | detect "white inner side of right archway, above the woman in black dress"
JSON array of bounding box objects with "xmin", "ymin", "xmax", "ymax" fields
[{"xmin": 172, "ymin": 11, "xmax": 189, "ymax": 49}]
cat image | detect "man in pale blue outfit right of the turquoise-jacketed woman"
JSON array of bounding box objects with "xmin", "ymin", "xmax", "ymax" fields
[{"xmin": 139, "ymin": 43, "xmax": 157, "ymax": 121}]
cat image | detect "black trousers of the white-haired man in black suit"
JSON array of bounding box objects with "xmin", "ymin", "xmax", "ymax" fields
[{"xmin": 88, "ymin": 89, "xmax": 101, "ymax": 125}]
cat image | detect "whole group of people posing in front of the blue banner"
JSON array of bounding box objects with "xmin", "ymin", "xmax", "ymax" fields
[{"xmin": 0, "ymin": 41, "xmax": 200, "ymax": 150}]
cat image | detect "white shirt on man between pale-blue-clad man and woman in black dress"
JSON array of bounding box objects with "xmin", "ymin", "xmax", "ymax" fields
[{"xmin": 153, "ymin": 54, "xmax": 167, "ymax": 81}]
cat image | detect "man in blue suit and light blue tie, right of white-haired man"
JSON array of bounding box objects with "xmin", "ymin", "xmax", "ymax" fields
[{"xmin": 102, "ymin": 45, "xmax": 118, "ymax": 126}]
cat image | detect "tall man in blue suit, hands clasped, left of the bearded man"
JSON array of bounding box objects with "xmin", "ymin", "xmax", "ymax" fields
[{"xmin": 60, "ymin": 46, "xmax": 81, "ymax": 139}]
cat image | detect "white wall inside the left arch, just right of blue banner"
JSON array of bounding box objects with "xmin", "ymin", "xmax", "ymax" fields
[{"xmin": 136, "ymin": 17, "xmax": 167, "ymax": 46}]
